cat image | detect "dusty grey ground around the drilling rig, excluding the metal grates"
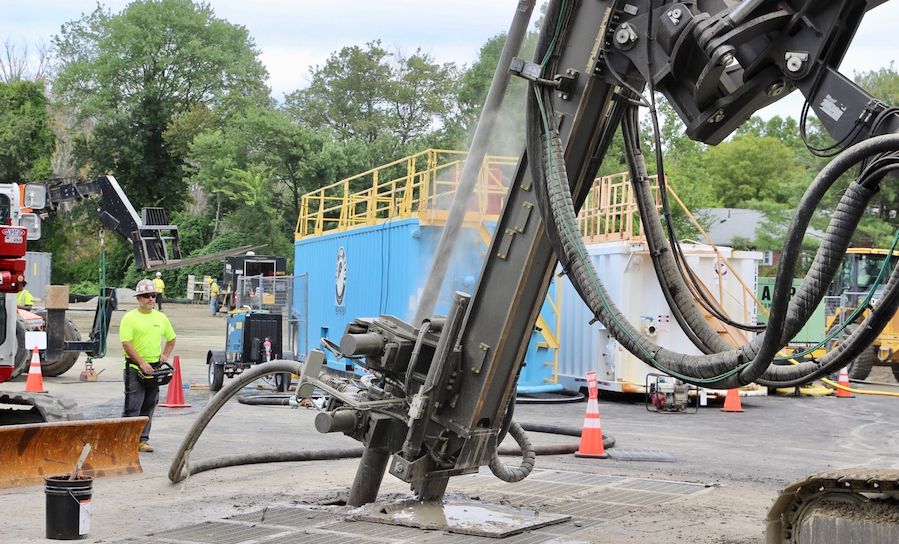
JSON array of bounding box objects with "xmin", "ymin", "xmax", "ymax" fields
[{"xmin": 0, "ymin": 304, "xmax": 899, "ymax": 544}]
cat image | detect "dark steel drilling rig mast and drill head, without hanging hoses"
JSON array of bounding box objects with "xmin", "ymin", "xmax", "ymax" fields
[{"xmin": 297, "ymin": 0, "xmax": 899, "ymax": 536}]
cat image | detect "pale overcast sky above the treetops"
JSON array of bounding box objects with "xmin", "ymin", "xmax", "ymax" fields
[{"xmin": 0, "ymin": 0, "xmax": 899, "ymax": 117}]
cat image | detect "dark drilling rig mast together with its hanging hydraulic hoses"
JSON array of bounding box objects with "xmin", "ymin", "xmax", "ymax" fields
[{"xmin": 298, "ymin": 0, "xmax": 899, "ymax": 532}]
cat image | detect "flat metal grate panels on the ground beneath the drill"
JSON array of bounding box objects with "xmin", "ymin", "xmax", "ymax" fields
[{"xmin": 126, "ymin": 470, "xmax": 706, "ymax": 544}]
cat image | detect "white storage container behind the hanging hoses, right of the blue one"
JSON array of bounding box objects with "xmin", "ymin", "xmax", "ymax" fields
[{"xmin": 558, "ymin": 241, "xmax": 762, "ymax": 393}]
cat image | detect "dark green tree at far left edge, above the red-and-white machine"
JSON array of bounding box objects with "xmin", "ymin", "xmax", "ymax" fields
[{"xmin": 0, "ymin": 81, "xmax": 55, "ymax": 183}]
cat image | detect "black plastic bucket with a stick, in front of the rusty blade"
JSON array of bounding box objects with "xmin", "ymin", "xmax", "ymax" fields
[{"xmin": 44, "ymin": 475, "xmax": 94, "ymax": 540}]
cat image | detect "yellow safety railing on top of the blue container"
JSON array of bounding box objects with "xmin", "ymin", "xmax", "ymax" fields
[{"xmin": 295, "ymin": 149, "xmax": 518, "ymax": 240}]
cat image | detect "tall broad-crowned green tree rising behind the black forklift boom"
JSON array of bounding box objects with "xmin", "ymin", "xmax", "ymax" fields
[{"xmin": 54, "ymin": 0, "xmax": 268, "ymax": 210}]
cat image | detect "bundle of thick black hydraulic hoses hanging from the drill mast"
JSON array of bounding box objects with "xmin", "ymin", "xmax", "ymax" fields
[{"xmin": 527, "ymin": 0, "xmax": 899, "ymax": 389}]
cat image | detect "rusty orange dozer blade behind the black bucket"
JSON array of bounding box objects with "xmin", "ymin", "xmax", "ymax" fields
[{"xmin": 0, "ymin": 417, "xmax": 147, "ymax": 488}]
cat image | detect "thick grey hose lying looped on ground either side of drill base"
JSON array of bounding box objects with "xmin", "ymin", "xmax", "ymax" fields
[{"xmin": 168, "ymin": 360, "xmax": 615, "ymax": 483}]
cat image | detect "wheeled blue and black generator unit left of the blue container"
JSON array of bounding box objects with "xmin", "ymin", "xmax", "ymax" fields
[{"xmin": 206, "ymin": 309, "xmax": 294, "ymax": 391}]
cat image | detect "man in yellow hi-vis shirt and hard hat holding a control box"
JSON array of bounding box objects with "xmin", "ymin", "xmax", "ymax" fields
[{"xmin": 119, "ymin": 280, "xmax": 175, "ymax": 452}]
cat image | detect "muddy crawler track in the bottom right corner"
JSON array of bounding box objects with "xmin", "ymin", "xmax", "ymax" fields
[{"xmin": 767, "ymin": 468, "xmax": 899, "ymax": 544}]
